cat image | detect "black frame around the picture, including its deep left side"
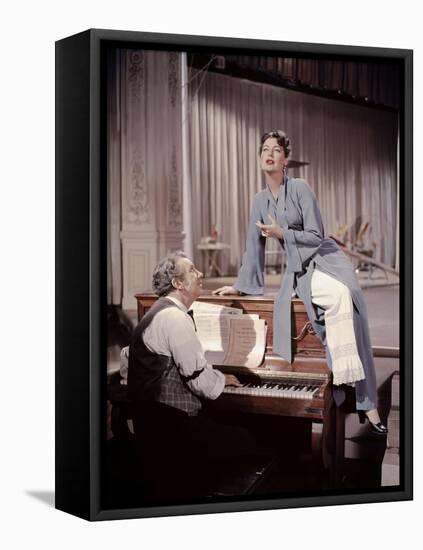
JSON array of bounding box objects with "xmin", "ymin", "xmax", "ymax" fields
[{"xmin": 55, "ymin": 29, "xmax": 413, "ymax": 521}]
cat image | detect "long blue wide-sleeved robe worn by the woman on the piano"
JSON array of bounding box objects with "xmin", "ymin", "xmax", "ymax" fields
[{"xmin": 234, "ymin": 178, "xmax": 376, "ymax": 405}]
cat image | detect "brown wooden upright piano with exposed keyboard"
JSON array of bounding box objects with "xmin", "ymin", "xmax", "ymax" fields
[{"xmin": 135, "ymin": 293, "xmax": 345, "ymax": 486}]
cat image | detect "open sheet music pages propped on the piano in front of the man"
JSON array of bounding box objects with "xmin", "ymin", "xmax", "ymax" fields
[{"xmin": 192, "ymin": 302, "xmax": 267, "ymax": 368}]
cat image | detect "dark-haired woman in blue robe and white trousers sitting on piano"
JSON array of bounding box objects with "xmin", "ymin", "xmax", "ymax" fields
[{"xmin": 214, "ymin": 130, "xmax": 388, "ymax": 435}]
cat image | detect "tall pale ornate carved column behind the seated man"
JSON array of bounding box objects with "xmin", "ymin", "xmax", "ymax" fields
[{"xmin": 121, "ymin": 50, "xmax": 182, "ymax": 309}]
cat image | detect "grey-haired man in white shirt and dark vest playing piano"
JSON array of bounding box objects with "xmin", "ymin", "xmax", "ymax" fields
[{"xmin": 128, "ymin": 252, "xmax": 255, "ymax": 494}]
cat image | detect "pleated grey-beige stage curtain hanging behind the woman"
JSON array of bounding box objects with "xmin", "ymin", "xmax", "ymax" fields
[{"xmin": 189, "ymin": 71, "xmax": 397, "ymax": 273}]
